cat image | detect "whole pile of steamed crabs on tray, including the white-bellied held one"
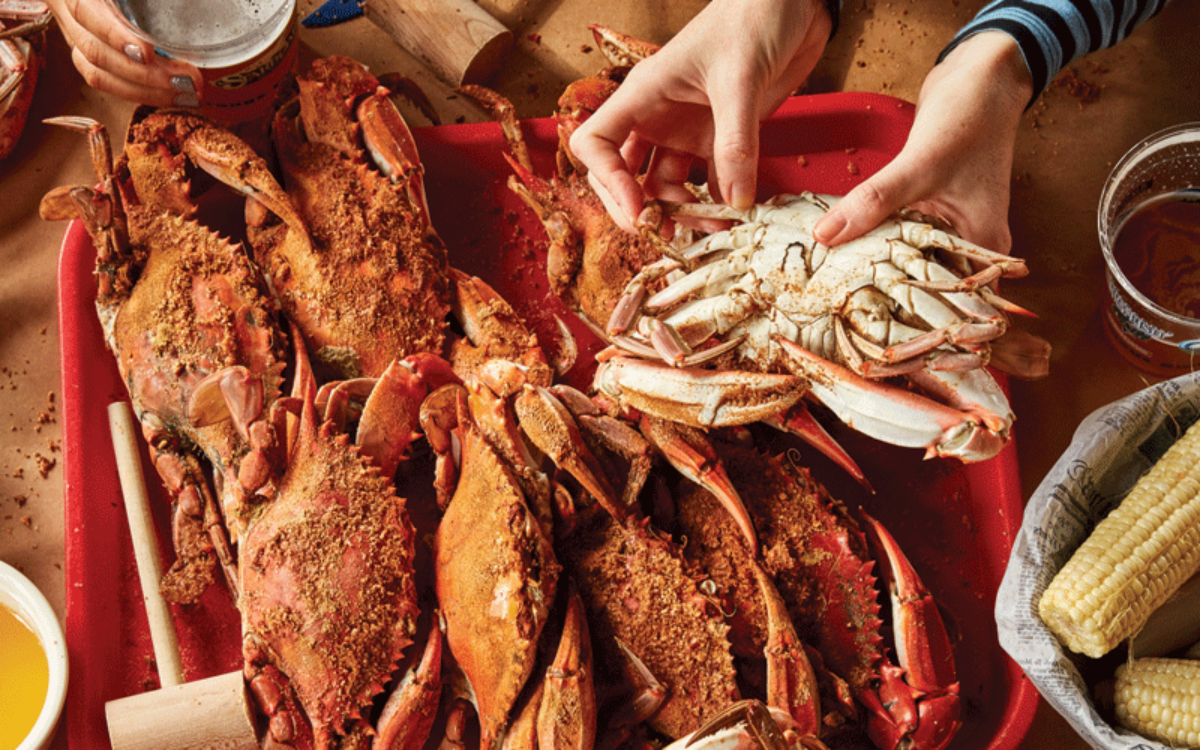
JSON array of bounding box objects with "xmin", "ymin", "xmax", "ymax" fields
[{"xmin": 41, "ymin": 26, "xmax": 1046, "ymax": 750}]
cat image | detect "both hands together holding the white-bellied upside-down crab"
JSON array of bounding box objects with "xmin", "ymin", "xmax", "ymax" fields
[{"xmin": 571, "ymin": 9, "xmax": 1032, "ymax": 260}]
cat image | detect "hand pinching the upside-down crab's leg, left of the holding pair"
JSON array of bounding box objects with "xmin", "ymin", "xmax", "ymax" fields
[{"xmin": 570, "ymin": 0, "xmax": 832, "ymax": 230}]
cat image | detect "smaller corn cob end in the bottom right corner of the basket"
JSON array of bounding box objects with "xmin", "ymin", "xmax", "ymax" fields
[{"xmin": 1114, "ymin": 658, "xmax": 1200, "ymax": 748}]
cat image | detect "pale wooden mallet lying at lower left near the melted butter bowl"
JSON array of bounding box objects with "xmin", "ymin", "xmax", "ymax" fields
[{"xmin": 104, "ymin": 402, "xmax": 259, "ymax": 750}]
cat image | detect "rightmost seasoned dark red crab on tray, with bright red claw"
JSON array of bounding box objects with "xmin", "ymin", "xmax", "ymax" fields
[{"xmin": 672, "ymin": 442, "xmax": 961, "ymax": 750}]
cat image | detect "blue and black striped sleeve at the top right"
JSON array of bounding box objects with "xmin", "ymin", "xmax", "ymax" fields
[{"xmin": 937, "ymin": 0, "xmax": 1170, "ymax": 103}]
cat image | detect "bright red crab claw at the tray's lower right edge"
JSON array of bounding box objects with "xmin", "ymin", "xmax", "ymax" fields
[{"xmin": 859, "ymin": 514, "xmax": 961, "ymax": 750}]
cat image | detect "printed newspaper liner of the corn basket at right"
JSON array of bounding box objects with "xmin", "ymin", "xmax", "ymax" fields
[{"xmin": 996, "ymin": 372, "xmax": 1200, "ymax": 750}]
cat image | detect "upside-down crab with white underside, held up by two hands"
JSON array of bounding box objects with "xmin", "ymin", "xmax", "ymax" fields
[{"xmin": 595, "ymin": 193, "xmax": 1051, "ymax": 461}]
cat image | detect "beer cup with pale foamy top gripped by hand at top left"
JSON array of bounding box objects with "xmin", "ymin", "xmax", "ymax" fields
[{"xmin": 108, "ymin": 0, "xmax": 299, "ymax": 124}]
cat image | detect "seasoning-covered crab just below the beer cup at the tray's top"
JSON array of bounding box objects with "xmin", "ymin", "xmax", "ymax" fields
[{"xmin": 260, "ymin": 56, "xmax": 450, "ymax": 378}]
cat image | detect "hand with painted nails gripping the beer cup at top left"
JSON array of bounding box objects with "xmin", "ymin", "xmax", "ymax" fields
[{"xmin": 48, "ymin": 0, "xmax": 204, "ymax": 107}]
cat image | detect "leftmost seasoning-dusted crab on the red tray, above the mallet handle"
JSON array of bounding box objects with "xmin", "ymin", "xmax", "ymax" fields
[{"xmin": 41, "ymin": 109, "xmax": 294, "ymax": 602}]
